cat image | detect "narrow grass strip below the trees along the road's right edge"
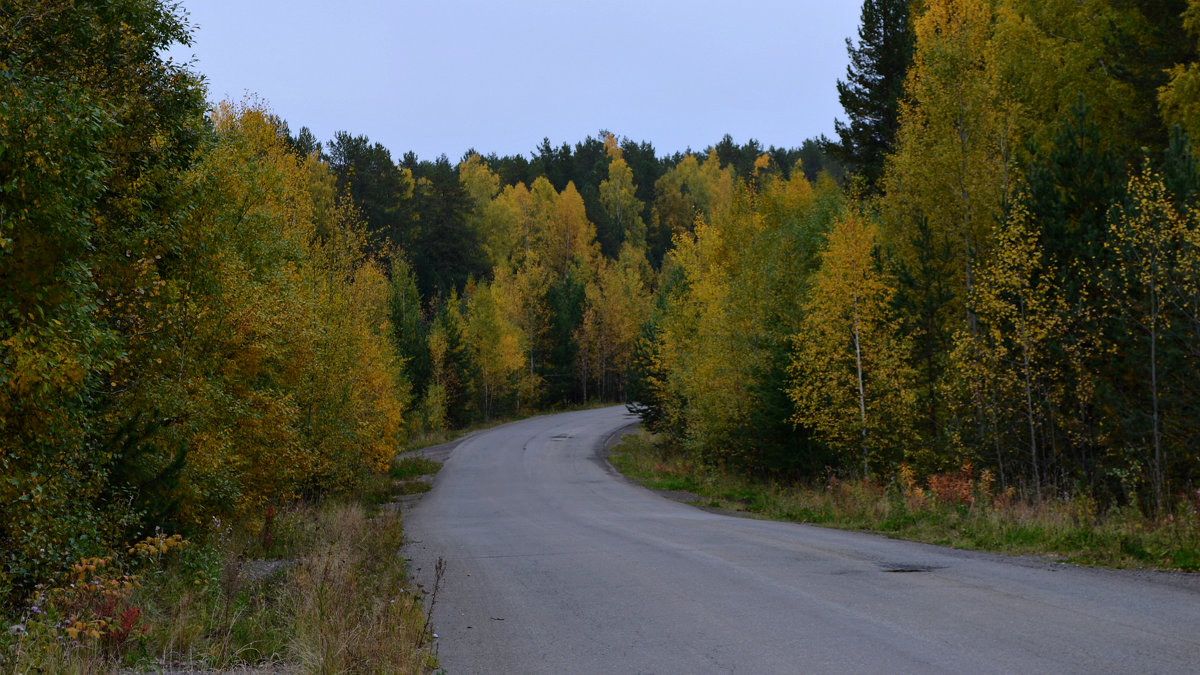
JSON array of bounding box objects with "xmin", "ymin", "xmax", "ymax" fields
[{"xmin": 610, "ymin": 432, "xmax": 1200, "ymax": 572}]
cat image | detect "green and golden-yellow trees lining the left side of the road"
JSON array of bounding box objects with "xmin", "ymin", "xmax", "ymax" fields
[{"xmin": 0, "ymin": 1, "xmax": 408, "ymax": 598}]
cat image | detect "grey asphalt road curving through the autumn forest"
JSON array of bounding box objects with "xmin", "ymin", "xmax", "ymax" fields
[{"xmin": 404, "ymin": 407, "xmax": 1200, "ymax": 675}]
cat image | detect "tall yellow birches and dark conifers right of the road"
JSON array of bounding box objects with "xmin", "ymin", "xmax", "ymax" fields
[{"xmin": 636, "ymin": 0, "xmax": 1200, "ymax": 513}]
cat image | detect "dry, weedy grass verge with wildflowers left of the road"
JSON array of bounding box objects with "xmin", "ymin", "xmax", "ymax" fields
[{"xmin": 0, "ymin": 460, "xmax": 437, "ymax": 674}]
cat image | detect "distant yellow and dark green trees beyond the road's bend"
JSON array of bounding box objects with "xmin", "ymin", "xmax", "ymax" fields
[{"xmin": 298, "ymin": 123, "xmax": 844, "ymax": 429}]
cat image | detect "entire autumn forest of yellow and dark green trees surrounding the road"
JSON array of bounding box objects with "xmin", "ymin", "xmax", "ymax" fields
[{"xmin": 0, "ymin": 0, "xmax": 1200, "ymax": 619}]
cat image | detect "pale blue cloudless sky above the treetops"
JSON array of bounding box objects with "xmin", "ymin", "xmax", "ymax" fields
[{"xmin": 172, "ymin": 0, "xmax": 862, "ymax": 161}]
